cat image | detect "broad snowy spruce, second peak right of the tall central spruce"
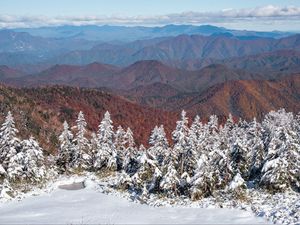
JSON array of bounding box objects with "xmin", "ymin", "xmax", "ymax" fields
[{"xmin": 191, "ymin": 116, "xmax": 232, "ymax": 192}]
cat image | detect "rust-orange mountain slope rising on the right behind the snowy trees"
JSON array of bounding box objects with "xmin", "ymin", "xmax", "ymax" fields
[{"xmin": 121, "ymin": 74, "xmax": 300, "ymax": 120}]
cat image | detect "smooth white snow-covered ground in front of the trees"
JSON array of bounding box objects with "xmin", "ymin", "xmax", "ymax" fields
[{"xmin": 0, "ymin": 178, "xmax": 270, "ymax": 224}]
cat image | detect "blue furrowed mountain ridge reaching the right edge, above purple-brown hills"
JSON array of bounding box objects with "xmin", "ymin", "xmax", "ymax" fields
[{"xmin": 48, "ymin": 35, "xmax": 300, "ymax": 66}]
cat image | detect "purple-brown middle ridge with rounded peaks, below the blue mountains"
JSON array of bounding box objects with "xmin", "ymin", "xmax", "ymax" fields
[{"xmin": 0, "ymin": 60, "xmax": 276, "ymax": 92}]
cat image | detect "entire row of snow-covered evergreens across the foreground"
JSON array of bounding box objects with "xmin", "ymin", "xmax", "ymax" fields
[{"xmin": 0, "ymin": 109, "xmax": 300, "ymax": 199}]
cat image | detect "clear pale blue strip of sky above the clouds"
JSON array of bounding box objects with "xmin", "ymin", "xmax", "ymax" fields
[{"xmin": 0, "ymin": 0, "xmax": 300, "ymax": 16}]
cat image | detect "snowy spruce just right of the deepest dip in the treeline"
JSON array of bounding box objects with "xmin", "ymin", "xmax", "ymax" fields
[{"xmin": 149, "ymin": 125, "xmax": 169, "ymax": 166}]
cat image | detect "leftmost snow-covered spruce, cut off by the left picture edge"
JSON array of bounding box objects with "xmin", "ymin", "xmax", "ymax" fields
[{"xmin": 0, "ymin": 111, "xmax": 20, "ymax": 170}]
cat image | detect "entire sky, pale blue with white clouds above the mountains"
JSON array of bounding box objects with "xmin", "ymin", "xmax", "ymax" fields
[{"xmin": 0, "ymin": 0, "xmax": 300, "ymax": 31}]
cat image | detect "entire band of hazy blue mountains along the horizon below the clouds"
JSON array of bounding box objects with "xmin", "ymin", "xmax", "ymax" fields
[{"xmin": 0, "ymin": 25, "xmax": 300, "ymax": 69}]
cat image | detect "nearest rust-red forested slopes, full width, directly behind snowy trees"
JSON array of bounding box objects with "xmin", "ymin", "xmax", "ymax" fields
[{"xmin": 0, "ymin": 75, "xmax": 300, "ymax": 151}]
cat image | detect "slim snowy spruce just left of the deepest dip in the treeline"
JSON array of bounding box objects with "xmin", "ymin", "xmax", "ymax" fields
[{"xmin": 123, "ymin": 127, "xmax": 139, "ymax": 175}]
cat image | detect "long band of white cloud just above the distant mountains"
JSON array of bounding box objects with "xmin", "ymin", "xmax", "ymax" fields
[{"xmin": 0, "ymin": 5, "xmax": 300, "ymax": 28}]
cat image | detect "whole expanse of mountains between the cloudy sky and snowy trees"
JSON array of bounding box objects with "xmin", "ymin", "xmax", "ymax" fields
[{"xmin": 0, "ymin": 25, "xmax": 300, "ymax": 147}]
